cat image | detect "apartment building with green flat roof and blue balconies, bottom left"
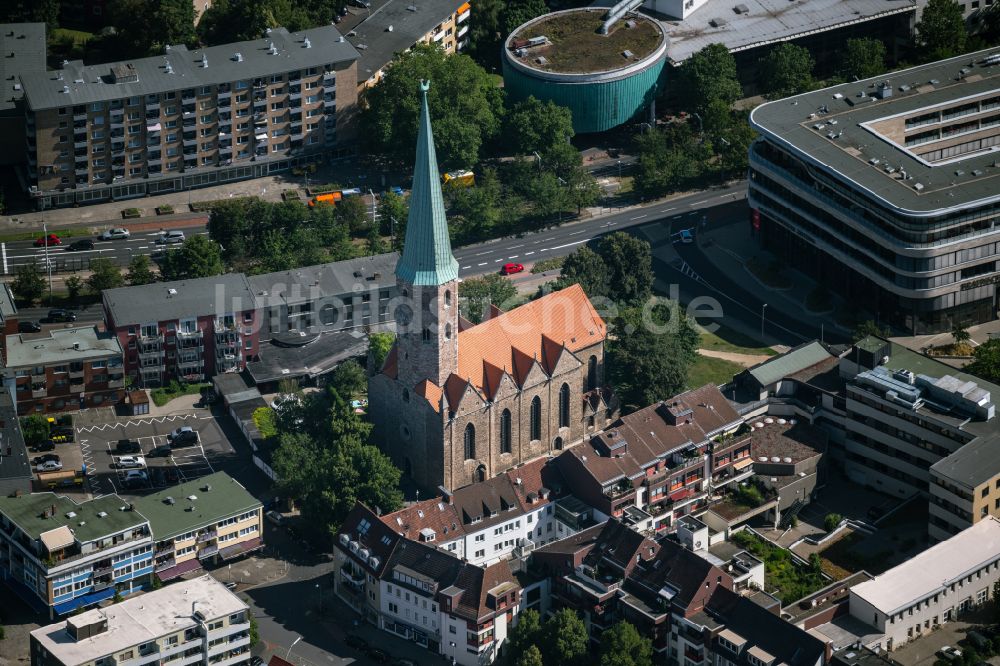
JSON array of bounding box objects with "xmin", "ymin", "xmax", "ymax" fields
[{"xmin": 0, "ymin": 493, "xmax": 153, "ymax": 617}]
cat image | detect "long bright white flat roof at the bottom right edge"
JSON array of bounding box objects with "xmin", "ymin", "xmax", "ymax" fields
[{"xmin": 851, "ymin": 516, "xmax": 1000, "ymax": 615}]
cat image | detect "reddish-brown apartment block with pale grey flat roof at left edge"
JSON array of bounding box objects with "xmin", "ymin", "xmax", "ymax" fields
[{"xmin": 2, "ymin": 326, "xmax": 125, "ymax": 414}]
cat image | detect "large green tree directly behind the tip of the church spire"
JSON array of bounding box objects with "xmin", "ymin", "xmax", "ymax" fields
[{"xmin": 361, "ymin": 44, "xmax": 503, "ymax": 169}]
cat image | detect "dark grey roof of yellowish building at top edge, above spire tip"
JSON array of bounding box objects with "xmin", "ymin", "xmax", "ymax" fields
[{"xmin": 347, "ymin": 0, "xmax": 468, "ymax": 85}]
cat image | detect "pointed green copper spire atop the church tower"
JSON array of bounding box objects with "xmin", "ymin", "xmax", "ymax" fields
[{"xmin": 396, "ymin": 81, "xmax": 458, "ymax": 286}]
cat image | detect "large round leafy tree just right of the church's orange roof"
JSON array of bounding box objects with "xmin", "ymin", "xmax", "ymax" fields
[{"xmin": 606, "ymin": 303, "xmax": 698, "ymax": 410}]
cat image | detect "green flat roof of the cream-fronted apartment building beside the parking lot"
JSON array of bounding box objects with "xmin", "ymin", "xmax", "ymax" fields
[{"xmin": 134, "ymin": 472, "xmax": 261, "ymax": 541}]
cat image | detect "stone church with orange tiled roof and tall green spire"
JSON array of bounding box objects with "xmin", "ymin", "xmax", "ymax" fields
[{"xmin": 368, "ymin": 82, "xmax": 616, "ymax": 490}]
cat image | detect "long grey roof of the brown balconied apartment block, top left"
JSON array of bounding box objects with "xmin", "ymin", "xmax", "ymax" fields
[{"xmin": 22, "ymin": 25, "xmax": 358, "ymax": 110}]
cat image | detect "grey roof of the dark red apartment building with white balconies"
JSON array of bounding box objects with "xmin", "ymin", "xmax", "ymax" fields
[{"xmin": 104, "ymin": 273, "xmax": 254, "ymax": 327}]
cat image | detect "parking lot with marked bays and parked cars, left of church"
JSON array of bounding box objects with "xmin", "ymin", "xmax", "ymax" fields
[{"xmin": 76, "ymin": 413, "xmax": 235, "ymax": 495}]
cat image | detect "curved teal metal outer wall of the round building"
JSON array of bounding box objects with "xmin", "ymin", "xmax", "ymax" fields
[{"xmin": 503, "ymin": 57, "xmax": 666, "ymax": 134}]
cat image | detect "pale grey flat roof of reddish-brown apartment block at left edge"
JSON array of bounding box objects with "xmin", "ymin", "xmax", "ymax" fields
[{"xmin": 4, "ymin": 326, "xmax": 122, "ymax": 368}]
